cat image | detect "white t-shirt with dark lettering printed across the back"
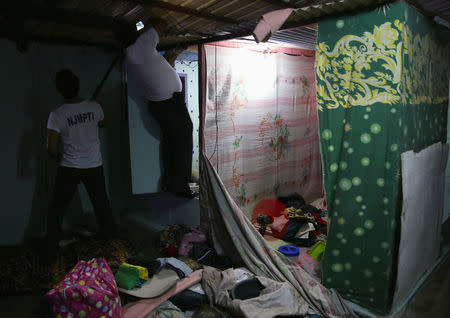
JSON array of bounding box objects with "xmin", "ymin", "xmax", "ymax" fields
[{"xmin": 47, "ymin": 101, "xmax": 104, "ymax": 169}]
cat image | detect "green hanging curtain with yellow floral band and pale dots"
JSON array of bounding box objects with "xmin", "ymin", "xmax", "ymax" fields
[{"xmin": 316, "ymin": 2, "xmax": 449, "ymax": 313}]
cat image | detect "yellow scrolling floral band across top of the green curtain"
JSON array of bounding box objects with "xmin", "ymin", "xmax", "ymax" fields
[{"xmin": 316, "ymin": 20, "xmax": 449, "ymax": 110}]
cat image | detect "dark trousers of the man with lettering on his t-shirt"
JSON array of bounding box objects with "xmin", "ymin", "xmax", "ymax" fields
[{"xmin": 47, "ymin": 166, "xmax": 116, "ymax": 257}]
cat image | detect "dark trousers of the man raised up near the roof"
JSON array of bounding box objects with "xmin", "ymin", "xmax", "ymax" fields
[{"xmin": 148, "ymin": 93, "xmax": 193, "ymax": 193}]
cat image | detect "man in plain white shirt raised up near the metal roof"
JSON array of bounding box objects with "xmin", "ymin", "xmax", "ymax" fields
[{"xmin": 126, "ymin": 19, "xmax": 193, "ymax": 197}]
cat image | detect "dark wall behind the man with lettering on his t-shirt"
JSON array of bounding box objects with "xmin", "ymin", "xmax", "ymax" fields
[{"xmin": 0, "ymin": 40, "xmax": 131, "ymax": 245}]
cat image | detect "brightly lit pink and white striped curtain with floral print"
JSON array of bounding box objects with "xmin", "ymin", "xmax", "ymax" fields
[{"xmin": 203, "ymin": 42, "xmax": 322, "ymax": 218}]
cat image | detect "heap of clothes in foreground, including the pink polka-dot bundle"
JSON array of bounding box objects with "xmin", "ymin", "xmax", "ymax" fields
[{"xmin": 46, "ymin": 258, "xmax": 324, "ymax": 318}]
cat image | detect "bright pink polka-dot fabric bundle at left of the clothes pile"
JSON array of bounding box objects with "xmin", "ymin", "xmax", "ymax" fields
[{"xmin": 46, "ymin": 258, "xmax": 124, "ymax": 318}]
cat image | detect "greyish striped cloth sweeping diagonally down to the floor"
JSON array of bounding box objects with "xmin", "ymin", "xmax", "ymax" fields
[{"xmin": 200, "ymin": 154, "xmax": 355, "ymax": 318}]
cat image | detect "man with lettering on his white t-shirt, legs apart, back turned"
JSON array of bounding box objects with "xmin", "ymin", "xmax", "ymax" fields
[{"xmin": 47, "ymin": 69, "xmax": 116, "ymax": 258}]
